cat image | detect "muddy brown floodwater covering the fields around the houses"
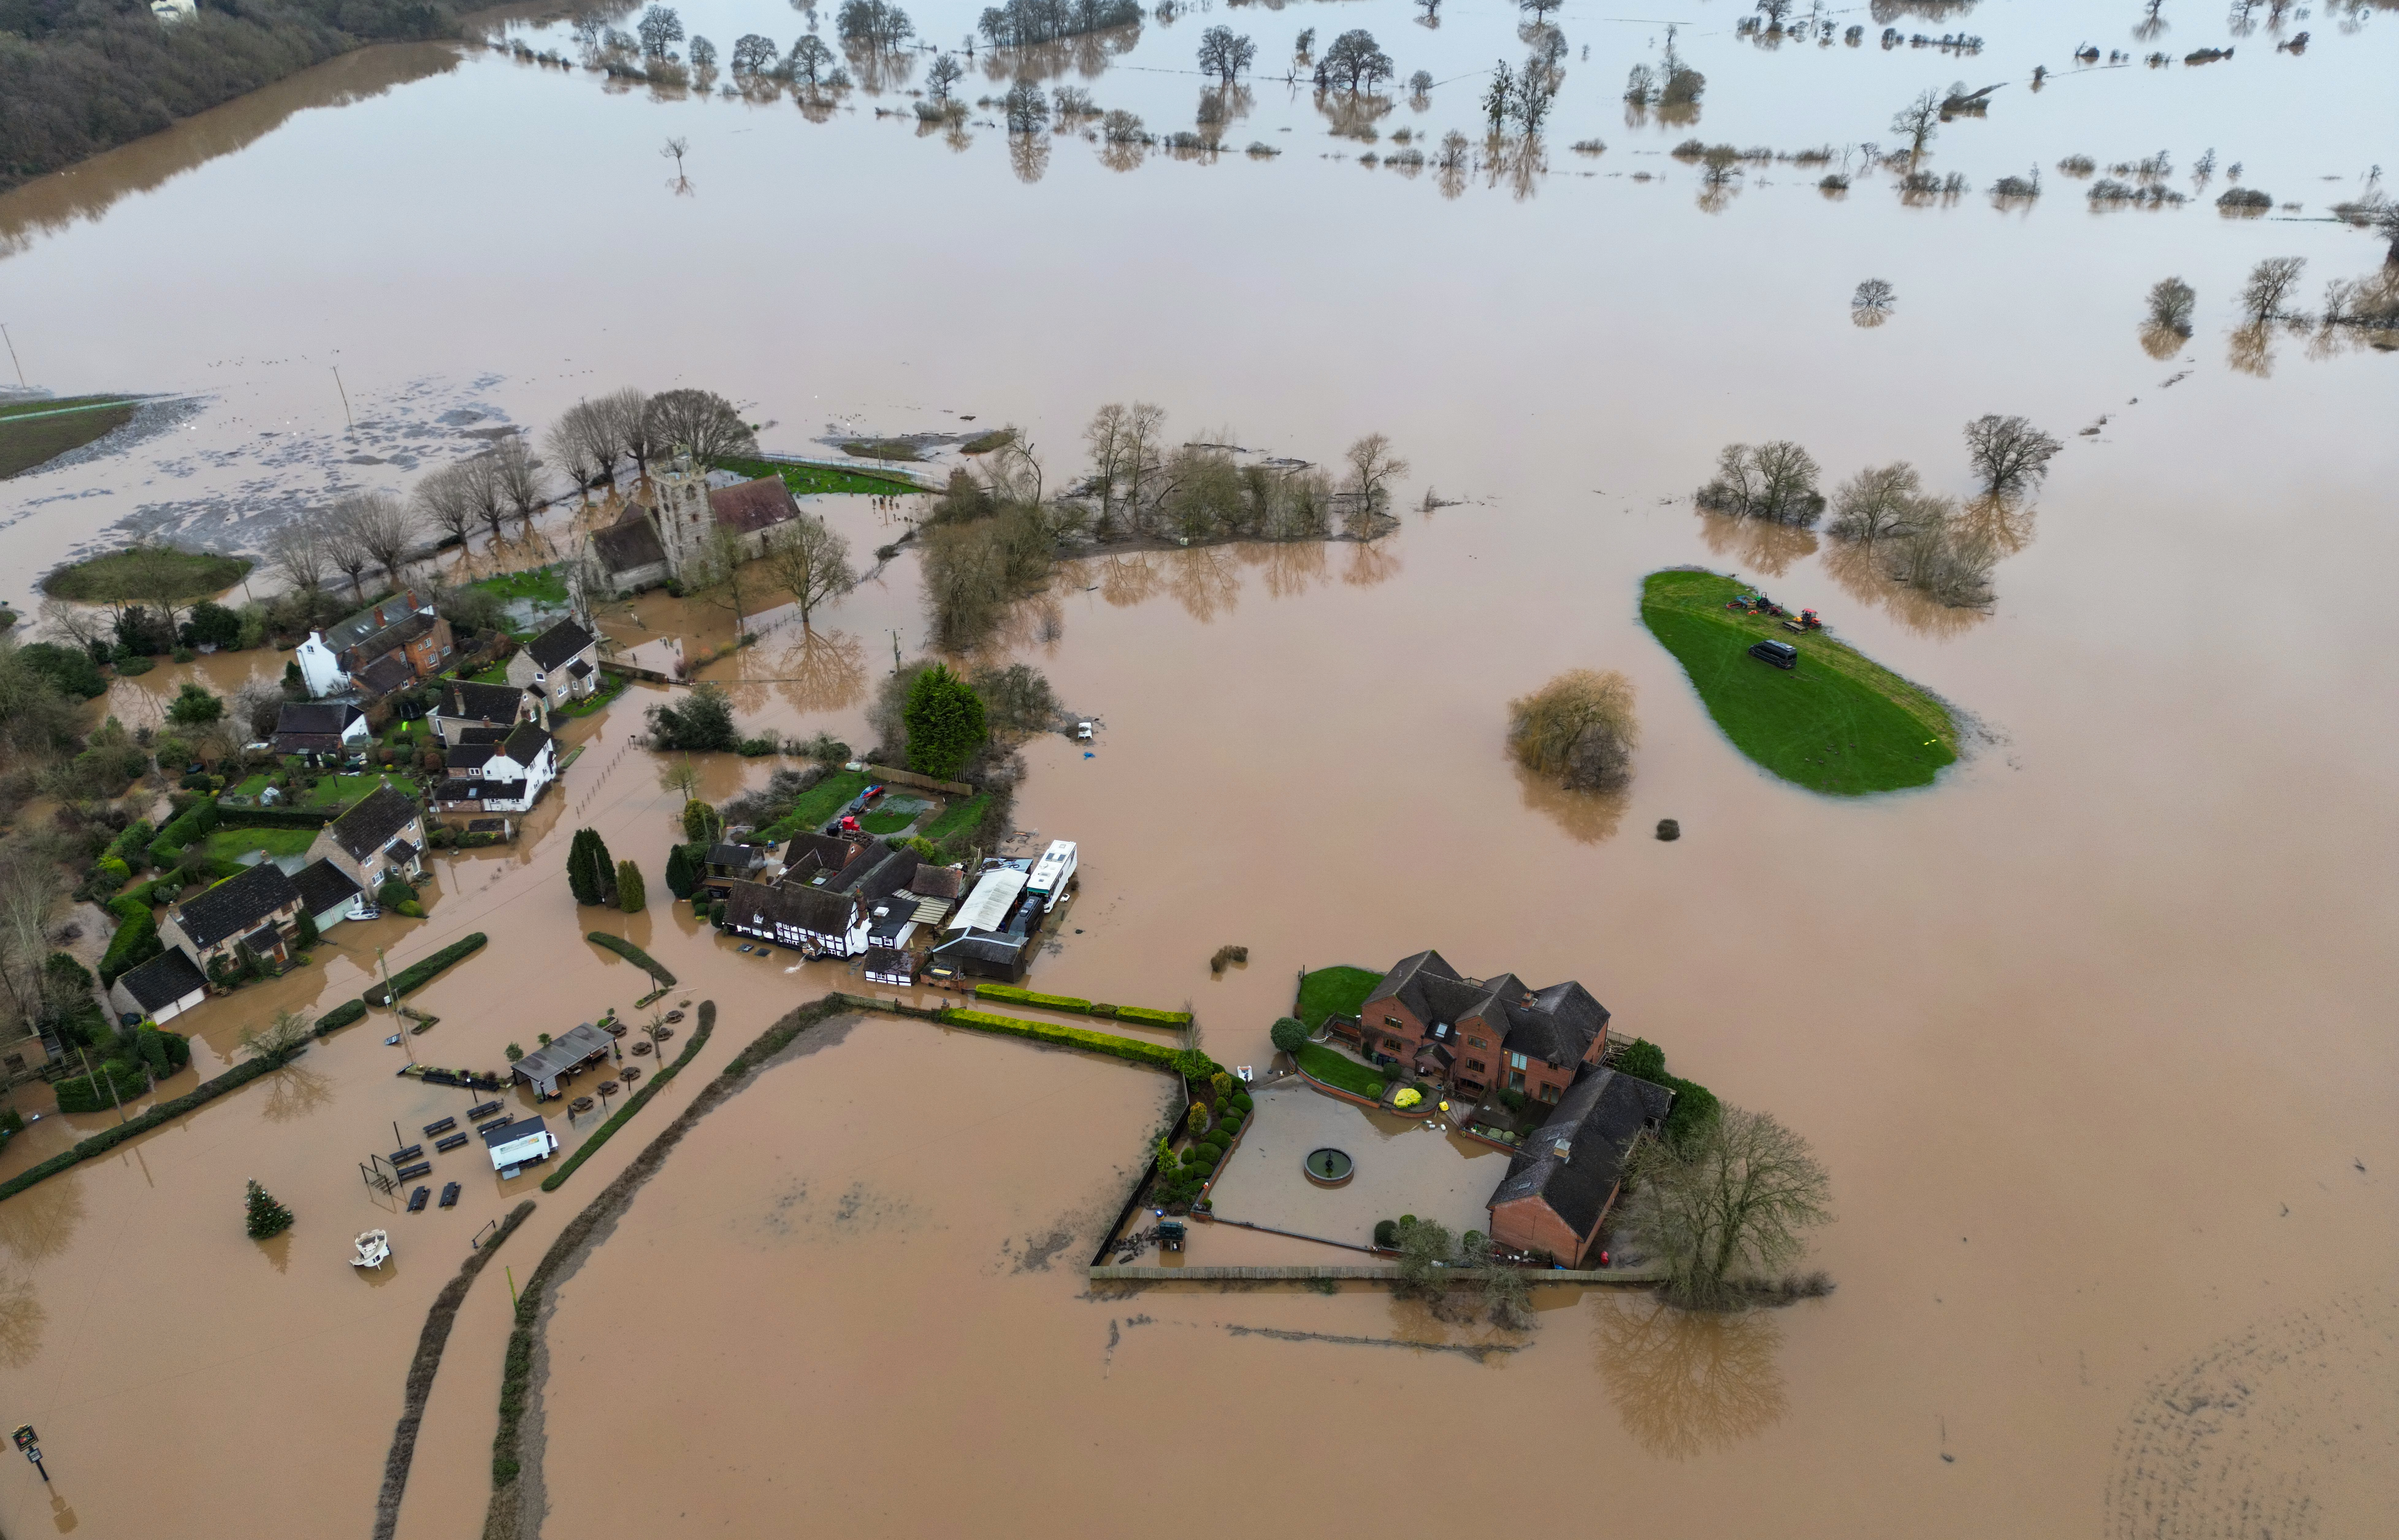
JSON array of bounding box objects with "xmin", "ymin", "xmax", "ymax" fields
[{"xmin": 0, "ymin": 0, "xmax": 2399, "ymax": 1540}]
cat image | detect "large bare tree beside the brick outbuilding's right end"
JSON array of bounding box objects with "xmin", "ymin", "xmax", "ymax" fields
[{"xmin": 1624, "ymin": 1106, "xmax": 1833, "ymax": 1310}]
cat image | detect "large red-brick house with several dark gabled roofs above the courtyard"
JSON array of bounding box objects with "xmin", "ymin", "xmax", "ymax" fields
[{"xmin": 1336, "ymin": 952, "xmax": 1607, "ymax": 1104}]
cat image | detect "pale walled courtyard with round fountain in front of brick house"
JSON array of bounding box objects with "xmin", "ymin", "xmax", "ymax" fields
[{"xmin": 1214, "ymin": 1079, "xmax": 1509, "ymax": 1245}]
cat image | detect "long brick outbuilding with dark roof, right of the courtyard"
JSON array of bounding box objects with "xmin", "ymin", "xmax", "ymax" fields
[{"xmin": 1490, "ymin": 1067, "xmax": 1674, "ymax": 1267}]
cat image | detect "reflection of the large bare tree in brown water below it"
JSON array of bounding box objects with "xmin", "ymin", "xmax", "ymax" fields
[{"xmin": 1590, "ymin": 1295, "xmax": 1785, "ymax": 1461}]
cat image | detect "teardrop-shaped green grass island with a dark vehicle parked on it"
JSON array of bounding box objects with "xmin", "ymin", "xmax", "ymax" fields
[{"xmin": 1641, "ymin": 569, "xmax": 1957, "ymax": 796}]
